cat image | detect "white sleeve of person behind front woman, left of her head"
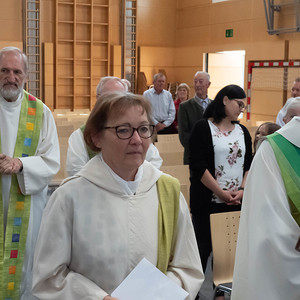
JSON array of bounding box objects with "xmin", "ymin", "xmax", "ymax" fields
[{"xmin": 66, "ymin": 128, "xmax": 89, "ymax": 176}]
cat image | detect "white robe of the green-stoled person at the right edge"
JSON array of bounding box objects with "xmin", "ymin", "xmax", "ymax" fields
[{"xmin": 231, "ymin": 117, "xmax": 300, "ymax": 300}]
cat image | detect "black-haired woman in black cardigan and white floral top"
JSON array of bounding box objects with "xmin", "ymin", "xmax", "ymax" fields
[{"xmin": 189, "ymin": 85, "xmax": 252, "ymax": 270}]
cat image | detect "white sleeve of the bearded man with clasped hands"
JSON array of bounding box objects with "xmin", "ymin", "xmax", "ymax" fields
[{"xmin": 17, "ymin": 105, "xmax": 60, "ymax": 195}]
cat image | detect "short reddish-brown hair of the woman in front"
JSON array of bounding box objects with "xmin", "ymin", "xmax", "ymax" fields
[{"xmin": 84, "ymin": 92, "xmax": 152, "ymax": 152}]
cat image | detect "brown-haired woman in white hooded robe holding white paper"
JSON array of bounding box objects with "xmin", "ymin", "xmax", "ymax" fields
[{"xmin": 33, "ymin": 93, "xmax": 203, "ymax": 300}]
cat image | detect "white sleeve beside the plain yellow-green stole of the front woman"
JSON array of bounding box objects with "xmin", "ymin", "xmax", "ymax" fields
[{"xmin": 167, "ymin": 193, "xmax": 204, "ymax": 300}]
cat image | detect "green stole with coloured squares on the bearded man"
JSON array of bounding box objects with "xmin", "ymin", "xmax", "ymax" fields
[{"xmin": 0, "ymin": 91, "xmax": 43, "ymax": 300}]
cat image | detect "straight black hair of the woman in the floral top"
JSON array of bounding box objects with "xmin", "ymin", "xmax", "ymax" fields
[{"xmin": 203, "ymin": 84, "xmax": 246, "ymax": 123}]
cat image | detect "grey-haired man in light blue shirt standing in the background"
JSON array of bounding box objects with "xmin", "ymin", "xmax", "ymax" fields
[{"xmin": 143, "ymin": 73, "xmax": 176, "ymax": 134}]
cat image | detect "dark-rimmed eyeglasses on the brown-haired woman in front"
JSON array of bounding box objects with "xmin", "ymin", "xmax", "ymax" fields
[{"xmin": 104, "ymin": 124, "xmax": 155, "ymax": 140}]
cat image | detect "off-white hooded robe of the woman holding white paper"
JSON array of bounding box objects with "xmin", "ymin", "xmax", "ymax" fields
[{"xmin": 33, "ymin": 155, "xmax": 203, "ymax": 300}]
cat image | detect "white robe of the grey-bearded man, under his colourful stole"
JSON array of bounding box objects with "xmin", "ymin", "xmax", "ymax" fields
[{"xmin": 0, "ymin": 93, "xmax": 60, "ymax": 300}]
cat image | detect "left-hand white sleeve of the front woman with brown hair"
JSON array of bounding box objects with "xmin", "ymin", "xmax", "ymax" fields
[{"xmin": 32, "ymin": 192, "xmax": 108, "ymax": 300}]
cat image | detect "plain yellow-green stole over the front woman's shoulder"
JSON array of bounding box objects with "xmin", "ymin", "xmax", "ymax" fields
[{"xmin": 156, "ymin": 175, "xmax": 180, "ymax": 274}]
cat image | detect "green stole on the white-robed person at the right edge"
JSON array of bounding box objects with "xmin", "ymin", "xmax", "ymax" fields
[{"xmin": 268, "ymin": 132, "xmax": 300, "ymax": 226}]
